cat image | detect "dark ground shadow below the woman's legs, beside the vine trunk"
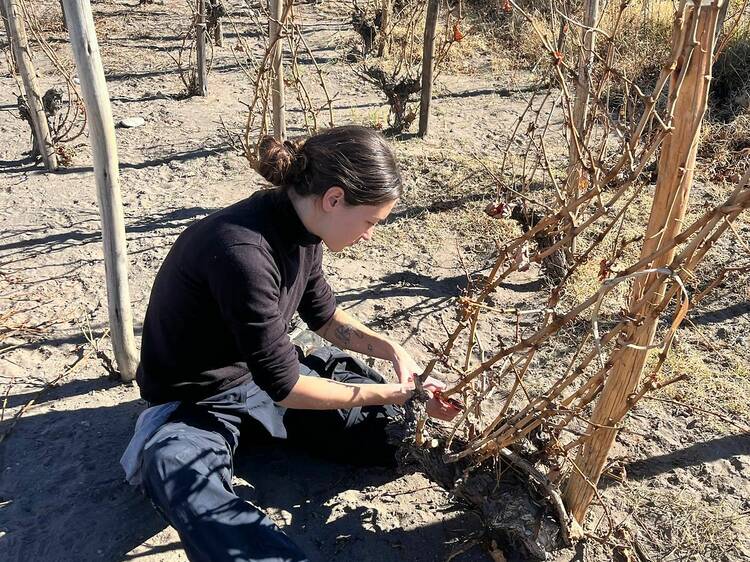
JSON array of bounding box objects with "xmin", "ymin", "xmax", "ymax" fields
[{"xmin": 235, "ymin": 444, "xmax": 490, "ymax": 562}]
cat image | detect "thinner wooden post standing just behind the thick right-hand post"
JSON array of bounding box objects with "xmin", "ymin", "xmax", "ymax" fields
[{"xmin": 561, "ymin": 0, "xmax": 599, "ymax": 254}]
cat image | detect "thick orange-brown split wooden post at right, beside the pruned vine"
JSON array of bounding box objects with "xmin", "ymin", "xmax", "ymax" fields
[{"xmin": 564, "ymin": 0, "xmax": 722, "ymax": 522}]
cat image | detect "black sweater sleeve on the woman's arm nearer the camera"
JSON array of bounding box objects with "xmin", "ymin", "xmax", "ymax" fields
[{"xmin": 209, "ymin": 244, "xmax": 299, "ymax": 402}]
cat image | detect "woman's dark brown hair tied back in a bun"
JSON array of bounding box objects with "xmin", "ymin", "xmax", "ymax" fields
[{"xmin": 256, "ymin": 125, "xmax": 402, "ymax": 205}]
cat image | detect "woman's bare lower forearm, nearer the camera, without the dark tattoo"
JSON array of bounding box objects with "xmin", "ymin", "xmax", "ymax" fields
[{"xmin": 279, "ymin": 376, "xmax": 412, "ymax": 410}]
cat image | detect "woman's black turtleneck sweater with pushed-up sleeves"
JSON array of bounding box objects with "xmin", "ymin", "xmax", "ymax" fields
[{"xmin": 137, "ymin": 190, "xmax": 336, "ymax": 404}]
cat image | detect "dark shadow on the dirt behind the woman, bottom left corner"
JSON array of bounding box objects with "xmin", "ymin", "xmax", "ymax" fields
[{"xmin": 0, "ymin": 390, "xmax": 164, "ymax": 562}]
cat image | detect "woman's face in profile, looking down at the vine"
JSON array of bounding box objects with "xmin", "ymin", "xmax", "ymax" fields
[{"xmin": 317, "ymin": 187, "xmax": 396, "ymax": 252}]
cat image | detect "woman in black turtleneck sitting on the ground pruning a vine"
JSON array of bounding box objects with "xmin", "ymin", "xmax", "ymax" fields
[{"xmin": 131, "ymin": 126, "xmax": 453, "ymax": 562}]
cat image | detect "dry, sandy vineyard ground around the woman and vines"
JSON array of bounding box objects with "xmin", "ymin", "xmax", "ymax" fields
[{"xmin": 0, "ymin": 0, "xmax": 750, "ymax": 562}]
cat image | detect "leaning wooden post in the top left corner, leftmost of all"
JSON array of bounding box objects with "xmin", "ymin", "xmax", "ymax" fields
[{"xmin": 2, "ymin": 0, "xmax": 57, "ymax": 172}]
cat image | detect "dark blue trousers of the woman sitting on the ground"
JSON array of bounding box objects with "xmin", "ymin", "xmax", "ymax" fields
[{"xmin": 143, "ymin": 348, "xmax": 402, "ymax": 562}]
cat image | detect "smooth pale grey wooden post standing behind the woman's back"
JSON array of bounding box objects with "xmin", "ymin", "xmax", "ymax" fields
[{"xmin": 64, "ymin": 0, "xmax": 138, "ymax": 381}]
